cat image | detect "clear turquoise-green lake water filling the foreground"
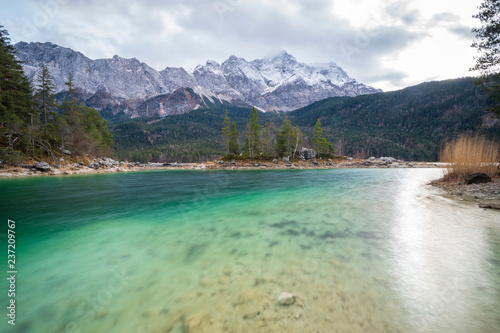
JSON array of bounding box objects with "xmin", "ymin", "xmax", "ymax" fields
[{"xmin": 0, "ymin": 169, "xmax": 500, "ymax": 333}]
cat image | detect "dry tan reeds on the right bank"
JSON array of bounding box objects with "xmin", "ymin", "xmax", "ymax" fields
[{"xmin": 440, "ymin": 135, "xmax": 500, "ymax": 180}]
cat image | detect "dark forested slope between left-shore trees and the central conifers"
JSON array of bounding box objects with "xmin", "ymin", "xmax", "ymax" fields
[{"xmin": 111, "ymin": 103, "xmax": 278, "ymax": 162}]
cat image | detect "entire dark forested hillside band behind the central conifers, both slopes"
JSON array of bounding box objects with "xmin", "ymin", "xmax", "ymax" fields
[{"xmin": 112, "ymin": 78, "xmax": 500, "ymax": 162}]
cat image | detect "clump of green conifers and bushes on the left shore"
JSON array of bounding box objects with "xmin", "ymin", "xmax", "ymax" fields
[{"xmin": 0, "ymin": 26, "xmax": 113, "ymax": 164}]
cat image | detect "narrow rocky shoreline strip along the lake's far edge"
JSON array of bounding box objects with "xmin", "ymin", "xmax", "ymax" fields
[{"xmin": 0, "ymin": 157, "xmax": 439, "ymax": 178}]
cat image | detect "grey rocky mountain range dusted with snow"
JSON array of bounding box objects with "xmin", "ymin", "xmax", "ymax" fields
[{"xmin": 15, "ymin": 42, "xmax": 380, "ymax": 116}]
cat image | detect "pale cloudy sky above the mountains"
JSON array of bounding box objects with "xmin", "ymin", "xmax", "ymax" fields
[{"xmin": 0, "ymin": 0, "xmax": 481, "ymax": 91}]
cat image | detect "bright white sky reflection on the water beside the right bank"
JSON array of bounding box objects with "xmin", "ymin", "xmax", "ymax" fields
[{"xmin": 392, "ymin": 171, "xmax": 500, "ymax": 332}]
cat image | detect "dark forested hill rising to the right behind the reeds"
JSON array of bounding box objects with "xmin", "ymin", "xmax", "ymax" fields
[{"xmin": 290, "ymin": 78, "xmax": 500, "ymax": 161}]
